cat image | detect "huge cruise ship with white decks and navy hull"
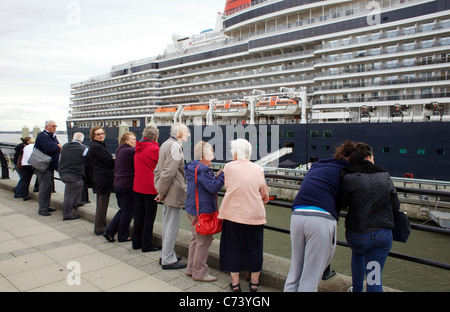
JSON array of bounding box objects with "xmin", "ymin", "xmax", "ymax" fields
[{"xmin": 67, "ymin": 0, "xmax": 450, "ymax": 180}]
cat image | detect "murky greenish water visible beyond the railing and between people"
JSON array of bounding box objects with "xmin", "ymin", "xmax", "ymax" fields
[{"xmin": 0, "ymin": 134, "xmax": 450, "ymax": 292}]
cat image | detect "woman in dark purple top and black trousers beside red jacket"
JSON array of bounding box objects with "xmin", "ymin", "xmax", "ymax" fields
[{"xmin": 103, "ymin": 132, "xmax": 136, "ymax": 242}]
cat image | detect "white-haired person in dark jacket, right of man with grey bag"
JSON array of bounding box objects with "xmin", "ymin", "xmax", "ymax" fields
[{"xmin": 58, "ymin": 132, "xmax": 89, "ymax": 221}]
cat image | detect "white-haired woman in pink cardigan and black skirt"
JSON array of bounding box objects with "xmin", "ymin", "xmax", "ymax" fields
[{"xmin": 219, "ymin": 139, "xmax": 269, "ymax": 292}]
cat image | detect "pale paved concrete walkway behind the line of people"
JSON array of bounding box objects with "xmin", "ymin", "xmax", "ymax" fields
[{"xmin": 0, "ymin": 179, "xmax": 277, "ymax": 292}]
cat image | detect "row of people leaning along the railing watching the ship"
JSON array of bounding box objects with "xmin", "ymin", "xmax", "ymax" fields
[{"xmin": 10, "ymin": 120, "xmax": 400, "ymax": 292}]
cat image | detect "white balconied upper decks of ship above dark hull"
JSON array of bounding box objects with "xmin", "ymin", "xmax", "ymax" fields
[{"xmin": 69, "ymin": 0, "xmax": 450, "ymax": 127}]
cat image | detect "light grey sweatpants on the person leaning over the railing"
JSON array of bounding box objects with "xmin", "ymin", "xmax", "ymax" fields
[{"xmin": 284, "ymin": 211, "xmax": 337, "ymax": 292}]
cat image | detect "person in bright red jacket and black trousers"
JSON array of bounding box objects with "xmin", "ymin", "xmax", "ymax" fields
[{"xmin": 131, "ymin": 124, "xmax": 161, "ymax": 252}]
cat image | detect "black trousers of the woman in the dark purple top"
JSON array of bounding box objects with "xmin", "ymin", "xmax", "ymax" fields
[{"xmin": 105, "ymin": 187, "xmax": 134, "ymax": 242}]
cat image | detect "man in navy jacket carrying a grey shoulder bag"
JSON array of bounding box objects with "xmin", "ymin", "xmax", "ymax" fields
[{"xmin": 34, "ymin": 120, "xmax": 62, "ymax": 216}]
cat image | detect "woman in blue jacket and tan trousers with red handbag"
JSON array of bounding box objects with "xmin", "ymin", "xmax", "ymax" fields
[{"xmin": 184, "ymin": 141, "xmax": 224, "ymax": 282}]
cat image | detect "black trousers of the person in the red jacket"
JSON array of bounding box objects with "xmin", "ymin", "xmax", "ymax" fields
[{"xmin": 131, "ymin": 192, "xmax": 158, "ymax": 251}]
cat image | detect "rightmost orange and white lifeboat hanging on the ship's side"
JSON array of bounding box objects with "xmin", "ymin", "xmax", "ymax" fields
[{"xmin": 255, "ymin": 96, "xmax": 300, "ymax": 115}]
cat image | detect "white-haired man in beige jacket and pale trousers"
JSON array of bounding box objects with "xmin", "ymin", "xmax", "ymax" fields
[{"xmin": 154, "ymin": 123, "xmax": 190, "ymax": 270}]
